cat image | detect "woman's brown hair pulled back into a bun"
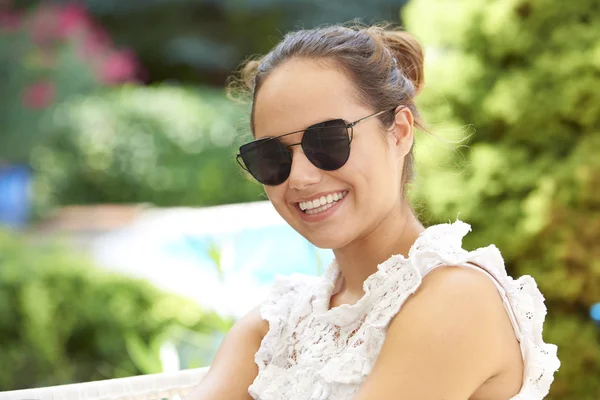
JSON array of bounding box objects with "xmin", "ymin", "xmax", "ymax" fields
[{"xmin": 228, "ymin": 24, "xmax": 426, "ymax": 191}]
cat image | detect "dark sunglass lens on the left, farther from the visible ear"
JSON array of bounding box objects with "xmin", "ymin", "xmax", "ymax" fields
[{"xmin": 240, "ymin": 139, "xmax": 292, "ymax": 185}]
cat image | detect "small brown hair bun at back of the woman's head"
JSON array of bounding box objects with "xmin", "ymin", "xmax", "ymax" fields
[{"xmin": 383, "ymin": 30, "xmax": 425, "ymax": 93}]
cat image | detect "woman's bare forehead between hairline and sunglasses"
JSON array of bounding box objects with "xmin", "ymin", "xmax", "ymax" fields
[{"xmin": 254, "ymin": 60, "xmax": 365, "ymax": 138}]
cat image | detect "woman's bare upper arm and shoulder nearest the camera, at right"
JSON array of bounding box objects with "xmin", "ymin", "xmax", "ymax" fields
[{"xmin": 355, "ymin": 266, "xmax": 506, "ymax": 400}]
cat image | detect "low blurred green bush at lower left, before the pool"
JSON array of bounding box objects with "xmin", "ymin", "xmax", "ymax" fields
[{"xmin": 0, "ymin": 231, "xmax": 231, "ymax": 391}]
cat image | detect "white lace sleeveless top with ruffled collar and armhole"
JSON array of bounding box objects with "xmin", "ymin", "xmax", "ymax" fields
[{"xmin": 248, "ymin": 221, "xmax": 560, "ymax": 400}]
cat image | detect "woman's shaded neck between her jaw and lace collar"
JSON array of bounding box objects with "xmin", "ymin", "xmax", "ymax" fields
[{"xmin": 333, "ymin": 201, "xmax": 424, "ymax": 299}]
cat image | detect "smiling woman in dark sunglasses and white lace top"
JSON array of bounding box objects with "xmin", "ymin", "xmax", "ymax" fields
[{"xmin": 189, "ymin": 26, "xmax": 560, "ymax": 400}]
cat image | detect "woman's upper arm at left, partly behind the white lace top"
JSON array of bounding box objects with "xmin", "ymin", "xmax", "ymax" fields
[{"xmin": 186, "ymin": 306, "xmax": 269, "ymax": 400}]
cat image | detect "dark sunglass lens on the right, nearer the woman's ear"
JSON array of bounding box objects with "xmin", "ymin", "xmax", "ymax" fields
[{"xmin": 302, "ymin": 119, "xmax": 350, "ymax": 171}]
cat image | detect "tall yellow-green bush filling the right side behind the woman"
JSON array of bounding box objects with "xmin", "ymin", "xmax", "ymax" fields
[{"xmin": 404, "ymin": 0, "xmax": 600, "ymax": 400}]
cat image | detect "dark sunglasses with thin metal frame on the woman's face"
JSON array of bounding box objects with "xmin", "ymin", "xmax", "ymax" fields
[{"xmin": 236, "ymin": 107, "xmax": 396, "ymax": 186}]
